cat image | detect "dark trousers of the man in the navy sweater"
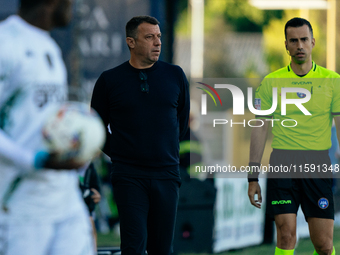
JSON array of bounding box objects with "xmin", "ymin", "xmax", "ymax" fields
[{"xmin": 112, "ymin": 176, "xmax": 180, "ymax": 255}]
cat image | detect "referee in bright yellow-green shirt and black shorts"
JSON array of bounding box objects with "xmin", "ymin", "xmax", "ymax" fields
[{"xmin": 248, "ymin": 18, "xmax": 340, "ymax": 255}]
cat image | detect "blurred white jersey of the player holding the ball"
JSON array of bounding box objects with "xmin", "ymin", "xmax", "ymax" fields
[{"xmin": 0, "ymin": 15, "xmax": 85, "ymax": 221}]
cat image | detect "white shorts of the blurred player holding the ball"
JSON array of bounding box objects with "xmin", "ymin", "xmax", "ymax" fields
[{"xmin": 0, "ymin": 212, "xmax": 95, "ymax": 255}]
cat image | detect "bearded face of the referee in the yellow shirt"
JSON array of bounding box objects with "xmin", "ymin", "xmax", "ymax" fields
[{"xmin": 285, "ymin": 25, "xmax": 315, "ymax": 64}]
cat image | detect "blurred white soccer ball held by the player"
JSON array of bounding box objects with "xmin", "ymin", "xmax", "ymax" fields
[{"xmin": 42, "ymin": 102, "xmax": 106, "ymax": 163}]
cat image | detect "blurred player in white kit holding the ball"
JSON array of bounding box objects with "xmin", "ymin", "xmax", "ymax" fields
[{"xmin": 0, "ymin": 0, "xmax": 94, "ymax": 255}]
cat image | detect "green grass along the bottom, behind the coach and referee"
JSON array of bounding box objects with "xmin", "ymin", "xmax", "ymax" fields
[{"xmin": 98, "ymin": 227, "xmax": 340, "ymax": 255}]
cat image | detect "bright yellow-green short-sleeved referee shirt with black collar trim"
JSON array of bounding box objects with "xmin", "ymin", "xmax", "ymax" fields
[{"xmin": 255, "ymin": 62, "xmax": 340, "ymax": 150}]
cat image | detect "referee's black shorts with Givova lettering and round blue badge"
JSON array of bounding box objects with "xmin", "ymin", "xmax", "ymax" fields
[{"xmin": 266, "ymin": 149, "xmax": 334, "ymax": 221}]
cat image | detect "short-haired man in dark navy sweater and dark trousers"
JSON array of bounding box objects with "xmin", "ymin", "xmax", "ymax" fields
[{"xmin": 91, "ymin": 16, "xmax": 190, "ymax": 255}]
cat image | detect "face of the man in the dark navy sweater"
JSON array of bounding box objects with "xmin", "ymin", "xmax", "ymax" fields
[{"xmin": 129, "ymin": 22, "xmax": 162, "ymax": 66}]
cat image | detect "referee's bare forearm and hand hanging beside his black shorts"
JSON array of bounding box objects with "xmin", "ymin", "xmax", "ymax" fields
[{"xmin": 248, "ymin": 121, "xmax": 269, "ymax": 209}]
